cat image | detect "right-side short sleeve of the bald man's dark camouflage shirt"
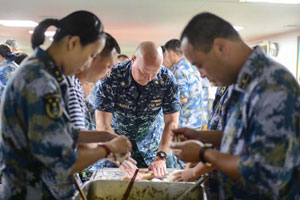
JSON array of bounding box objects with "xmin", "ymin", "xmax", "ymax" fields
[{"xmin": 162, "ymin": 75, "xmax": 180, "ymax": 114}]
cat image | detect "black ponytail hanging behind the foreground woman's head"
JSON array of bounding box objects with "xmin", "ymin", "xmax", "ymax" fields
[{"xmin": 31, "ymin": 19, "xmax": 59, "ymax": 49}]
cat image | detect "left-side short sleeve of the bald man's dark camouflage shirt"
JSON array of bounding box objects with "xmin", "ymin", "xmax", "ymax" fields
[{"xmin": 89, "ymin": 76, "xmax": 117, "ymax": 113}]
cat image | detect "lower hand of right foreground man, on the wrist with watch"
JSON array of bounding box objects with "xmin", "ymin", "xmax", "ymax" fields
[{"xmin": 171, "ymin": 140, "xmax": 203, "ymax": 162}]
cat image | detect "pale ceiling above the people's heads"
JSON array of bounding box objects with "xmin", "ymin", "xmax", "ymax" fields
[{"xmin": 0, "ymin": 0, "xmax": 300, "ymax": 55}]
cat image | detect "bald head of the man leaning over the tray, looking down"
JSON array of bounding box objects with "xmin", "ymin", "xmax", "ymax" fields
[{"xmin": 132, "ymin": 41, "xmax": 163, "ymax": 85}]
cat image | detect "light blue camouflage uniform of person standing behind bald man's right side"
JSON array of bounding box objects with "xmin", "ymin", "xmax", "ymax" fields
[{"xmin": 174, "ymin": 58, "xmax": 206, "ymax": 129}]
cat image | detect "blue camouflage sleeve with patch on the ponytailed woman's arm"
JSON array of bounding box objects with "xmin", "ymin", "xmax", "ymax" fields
[{"xmin": 18, "ymin": 78, "xmax": 77, "ymax": 195}]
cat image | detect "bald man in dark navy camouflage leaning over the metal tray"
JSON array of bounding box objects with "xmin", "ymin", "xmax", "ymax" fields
[{"xmin": 91, "ymin": 42, "xmax": 180, "ymax": 176}]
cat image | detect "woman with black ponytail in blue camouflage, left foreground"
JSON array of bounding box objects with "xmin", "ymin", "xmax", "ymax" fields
[{"xmin": 0, "ymin": 11, "xmax": 131, "ymax": 200}]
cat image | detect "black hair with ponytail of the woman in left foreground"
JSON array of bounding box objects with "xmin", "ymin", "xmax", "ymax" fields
[{"xmin": 31, "ymin": 11, "xmax": 103, "ymax": 49}]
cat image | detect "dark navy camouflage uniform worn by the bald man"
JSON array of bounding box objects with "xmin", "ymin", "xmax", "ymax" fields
[{"xmin": 90, "ymin": 61, "xmax": 180, "ymax": 167}]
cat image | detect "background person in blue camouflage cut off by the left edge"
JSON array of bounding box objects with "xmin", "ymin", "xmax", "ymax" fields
[{"xmin": 0, "ymin": 44, "xmax": 18, "ymax": 98}]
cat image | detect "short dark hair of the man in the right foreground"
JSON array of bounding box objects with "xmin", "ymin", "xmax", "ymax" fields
[{"xmin": 180, "ymin": 12, "xmax": 241, "ymax": 53}]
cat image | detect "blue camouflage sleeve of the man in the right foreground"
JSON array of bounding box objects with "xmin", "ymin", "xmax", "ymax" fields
[{"xmin": 239, "ymin": 81, "xmax": 300, "ymax": 192}]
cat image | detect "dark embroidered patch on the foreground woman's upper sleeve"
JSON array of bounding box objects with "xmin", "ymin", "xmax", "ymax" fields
[{"xmin": 44, "ymin": 94, "xmax": 63, "ymax": 120}]
